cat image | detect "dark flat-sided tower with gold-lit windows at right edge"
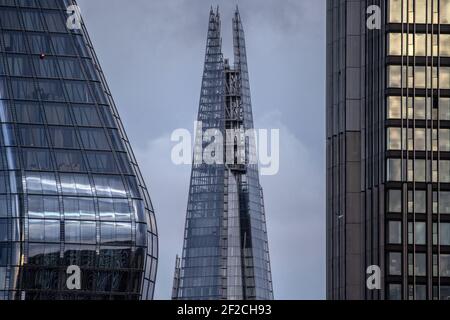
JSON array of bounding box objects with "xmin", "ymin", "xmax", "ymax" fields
[{"xmin": 327, "ymin": 0, "xmax": 450, "ymax": 300}]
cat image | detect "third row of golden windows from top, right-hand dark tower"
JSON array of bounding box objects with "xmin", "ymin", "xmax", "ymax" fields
[{"xmin": 387, "ymin": 65, "xmax": 450, "ymax": 89}]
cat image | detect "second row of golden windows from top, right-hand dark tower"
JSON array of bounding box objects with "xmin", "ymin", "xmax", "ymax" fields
[{"xmin": 388, "ymin": 33, "xmax": 450, "ymax": 57}]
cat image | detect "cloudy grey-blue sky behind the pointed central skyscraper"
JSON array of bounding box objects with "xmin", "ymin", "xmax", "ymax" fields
[{"xmin": 78, "ymin": 0, "xmax": 326, "ymax": 300}]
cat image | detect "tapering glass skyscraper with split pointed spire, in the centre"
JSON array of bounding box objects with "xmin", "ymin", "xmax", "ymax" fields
[{"xmin": 173, "ymin": 9, "xmax": 273, "ymax": 300}]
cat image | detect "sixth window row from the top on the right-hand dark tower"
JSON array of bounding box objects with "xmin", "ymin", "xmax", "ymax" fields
[{"xmin": 387, "ymin": 158, "xmax": 450, "ymax": 183}]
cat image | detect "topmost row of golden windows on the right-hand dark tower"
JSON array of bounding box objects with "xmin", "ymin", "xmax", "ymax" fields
[{"xmin": 388, "ymin": 0, "xmax": 450, "ymax": 24}]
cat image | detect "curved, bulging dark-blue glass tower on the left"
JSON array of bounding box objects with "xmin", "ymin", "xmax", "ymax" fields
[{"xmin": 0, "ymin": 0, "xmax": 157, "ymax": 300}]
